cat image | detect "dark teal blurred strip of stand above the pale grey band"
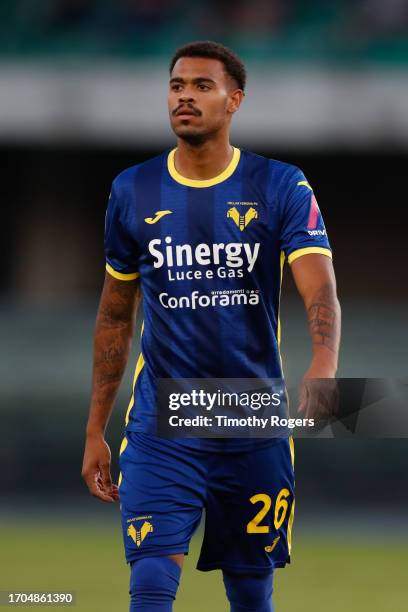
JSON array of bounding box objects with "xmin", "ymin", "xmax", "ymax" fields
[{"xmin": 0, "ymin": 0, "xmax": 408, "ymax": 65}]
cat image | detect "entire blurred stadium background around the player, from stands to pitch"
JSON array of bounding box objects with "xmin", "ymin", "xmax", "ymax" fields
[{"xmin": 0, "ymin": 0, "xmax": 408, "ymax": 612}]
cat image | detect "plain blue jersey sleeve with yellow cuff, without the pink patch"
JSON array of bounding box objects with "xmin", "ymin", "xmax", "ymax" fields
[{"xmin": 104, "ymin": 182, "xmax": 139, "ymax": 280}]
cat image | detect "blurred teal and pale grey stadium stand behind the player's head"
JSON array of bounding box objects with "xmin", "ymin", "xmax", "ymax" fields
[{"xmin": 0, "ymin": 0, "xmax": 408, "ymax": 150}]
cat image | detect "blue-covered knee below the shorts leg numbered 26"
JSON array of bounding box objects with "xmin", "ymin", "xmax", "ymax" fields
[{"xmin": 223, "ymin": 572, "xmax": 273, "ymax": 612}]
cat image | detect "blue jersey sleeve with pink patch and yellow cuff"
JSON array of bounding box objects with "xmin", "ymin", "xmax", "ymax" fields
[{"xmin": 279, "ymin": 167, "xmax": 332, "ymax": 264}]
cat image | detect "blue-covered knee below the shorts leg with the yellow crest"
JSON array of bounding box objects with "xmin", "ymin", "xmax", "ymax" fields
[{"xmin": 129, "ymin": 557, "xmax": 181, "ymax": 610}]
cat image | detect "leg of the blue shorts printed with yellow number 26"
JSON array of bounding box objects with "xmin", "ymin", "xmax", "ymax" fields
[{"xmin": 197, "ymin": 439, "xmax": 294, "ymax": 574}]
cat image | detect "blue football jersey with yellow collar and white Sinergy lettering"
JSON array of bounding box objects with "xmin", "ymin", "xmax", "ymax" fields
[{"xmin": 105, "ymin": 148, "xmax": 331, "ymax": 432}]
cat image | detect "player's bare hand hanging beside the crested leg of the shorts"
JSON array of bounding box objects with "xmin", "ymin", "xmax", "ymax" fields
[{"xmin": 82, "ymin": 434, "xmax": 119, "ymax": 503}]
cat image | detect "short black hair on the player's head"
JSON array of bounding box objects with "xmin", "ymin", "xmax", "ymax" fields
[{"xmin": 170, "ymin": 40, "xmax": 246, "ymax": 91}]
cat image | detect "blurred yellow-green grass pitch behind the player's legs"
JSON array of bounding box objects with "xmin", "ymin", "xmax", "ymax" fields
[{"xmin": 0, "ymin": 516, "xmax": 408, "ymax": 612}]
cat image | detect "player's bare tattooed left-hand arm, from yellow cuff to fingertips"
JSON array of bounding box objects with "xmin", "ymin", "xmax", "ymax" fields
[{"xmin": 82, "ymin": 273, "xmax": 140, "ymax": 502}]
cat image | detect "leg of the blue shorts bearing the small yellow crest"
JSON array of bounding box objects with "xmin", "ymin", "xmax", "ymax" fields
[{"xmin": 119, "ymin": 432, "xmax": 206, "ymax": 562}]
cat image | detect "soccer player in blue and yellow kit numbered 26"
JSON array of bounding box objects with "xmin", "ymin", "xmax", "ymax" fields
[{"xmin": 82, "ymin": 42, "xmax": 340, "ymax": 612}]
